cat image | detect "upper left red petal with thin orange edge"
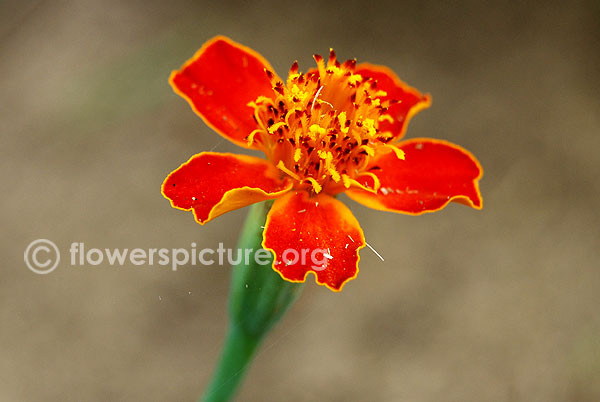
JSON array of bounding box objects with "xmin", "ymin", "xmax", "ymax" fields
[{"xmin": 169, "ymin": 36, "xmax": 274, "ymax": 148}]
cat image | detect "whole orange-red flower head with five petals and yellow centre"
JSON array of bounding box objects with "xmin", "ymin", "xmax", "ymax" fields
[{"xmin": 162, "ymin": 37, "xmax": 482, "ymax": 291}]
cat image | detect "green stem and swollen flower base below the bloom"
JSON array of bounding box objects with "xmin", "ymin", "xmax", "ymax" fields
[{"xmin": 202, "ymin": 202, "xmax": 303, "ymax": 402}]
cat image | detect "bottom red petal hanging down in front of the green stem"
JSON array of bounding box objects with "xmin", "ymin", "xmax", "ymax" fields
[{"xmin": 263, "ymin": 191, "xmax": 365, "ymax": 292}]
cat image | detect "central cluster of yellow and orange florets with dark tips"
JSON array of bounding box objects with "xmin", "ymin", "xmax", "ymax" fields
[{"xmin": 247, "ymin": 49, "xmax": 404, "ymax": 194}]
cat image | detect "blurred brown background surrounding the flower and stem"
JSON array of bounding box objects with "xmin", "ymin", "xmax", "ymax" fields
[{"xmin": 0, "ymin": 0, "xmax": 600, "ymax": 402}]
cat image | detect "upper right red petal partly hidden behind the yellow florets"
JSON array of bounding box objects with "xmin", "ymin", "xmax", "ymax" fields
[{"xmin": 356, "ymin": 63, "xmax": 431, "ymax": 139}]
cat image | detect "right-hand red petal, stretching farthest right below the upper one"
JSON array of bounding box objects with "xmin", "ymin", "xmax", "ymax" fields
[{"xmin": 346, "ymin": 138, "xmax": 483, "ymax": 215}]
